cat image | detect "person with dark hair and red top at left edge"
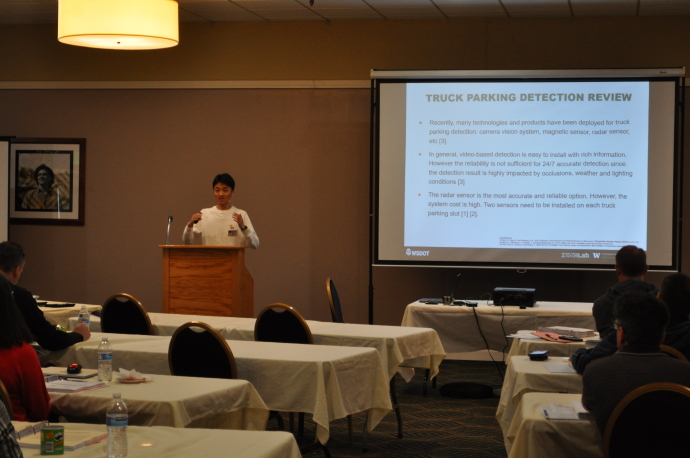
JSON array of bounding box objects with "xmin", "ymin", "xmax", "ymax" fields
[{"xmin": 0, "ymin": 277, "xmax": 50, "ymax": 421}]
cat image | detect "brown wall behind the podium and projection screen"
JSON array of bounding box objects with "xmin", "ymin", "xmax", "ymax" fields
[{"xmin": 0, "ymin": 17, "xmax": 690, "ymax": 324}]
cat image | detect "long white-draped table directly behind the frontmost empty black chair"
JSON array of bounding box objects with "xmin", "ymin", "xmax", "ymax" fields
[{"xmin": 53, "ymin": 333, "xmax": 392, "ymax": 444}]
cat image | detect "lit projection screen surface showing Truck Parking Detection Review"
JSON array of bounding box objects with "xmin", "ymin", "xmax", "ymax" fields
[{"xmin": 379, "ymin": 80, "xmax": 673, "ymax": 264}]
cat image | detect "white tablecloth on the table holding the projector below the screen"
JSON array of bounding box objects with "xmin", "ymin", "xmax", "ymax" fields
[{"xmin": 402, "ymin": 302, "xmax": 595, "ymax": 353}]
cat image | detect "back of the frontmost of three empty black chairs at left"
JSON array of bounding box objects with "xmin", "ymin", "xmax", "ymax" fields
[{"xmin": 168, "ymin": 321, "xmax": 237, "ymax": 379}]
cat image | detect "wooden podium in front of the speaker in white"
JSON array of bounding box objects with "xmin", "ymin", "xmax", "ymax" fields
[{"xmin": 159, "ymin": 245, "xmax": 254, "ymax": 318}]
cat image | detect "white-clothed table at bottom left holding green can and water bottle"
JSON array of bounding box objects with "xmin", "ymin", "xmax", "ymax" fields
[{"xmin": 12, "ymin": 421, "xmax": 302, "ymax": 458}]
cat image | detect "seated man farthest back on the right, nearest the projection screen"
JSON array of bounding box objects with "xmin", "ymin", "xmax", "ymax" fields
[{"xmin": 592, "ymin": 245, "xmax": 657, "ymax": 339}]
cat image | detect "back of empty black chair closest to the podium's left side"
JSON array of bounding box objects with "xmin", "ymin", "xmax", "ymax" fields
[{"xmin": 101, "ymin": 293, "xmax": 154, "ymax": 336}]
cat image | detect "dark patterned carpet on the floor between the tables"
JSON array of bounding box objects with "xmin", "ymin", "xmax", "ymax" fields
[{"xmin": 276, "ymin": 361, "xmax": 506, "ymax": 458}]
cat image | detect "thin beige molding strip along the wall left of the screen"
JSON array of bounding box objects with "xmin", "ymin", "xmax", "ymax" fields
[{"xmin": 0, "ymin": 80, "xmax": 371, "ymax": 89}]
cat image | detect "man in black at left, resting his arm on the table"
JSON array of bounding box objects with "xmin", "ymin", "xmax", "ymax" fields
[{"xmin": 0, "ymin": 242, "xmax": 91, "ymax": 353}]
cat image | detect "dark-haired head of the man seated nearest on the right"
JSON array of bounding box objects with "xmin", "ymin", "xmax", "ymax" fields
[{"xmin": 613, "ymin": 291, "xmax": 669, "ymax": 348}]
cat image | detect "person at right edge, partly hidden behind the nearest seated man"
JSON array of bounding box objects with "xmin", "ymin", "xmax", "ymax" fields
[{"xmin": 571, "ymin": 273, "xmax": 690, "ymax": 374}]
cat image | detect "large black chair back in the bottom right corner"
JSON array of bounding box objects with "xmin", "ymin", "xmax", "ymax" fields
[{"xmin": 604, "ymin": 383, "xmax": 690, "ymax": 458}]
